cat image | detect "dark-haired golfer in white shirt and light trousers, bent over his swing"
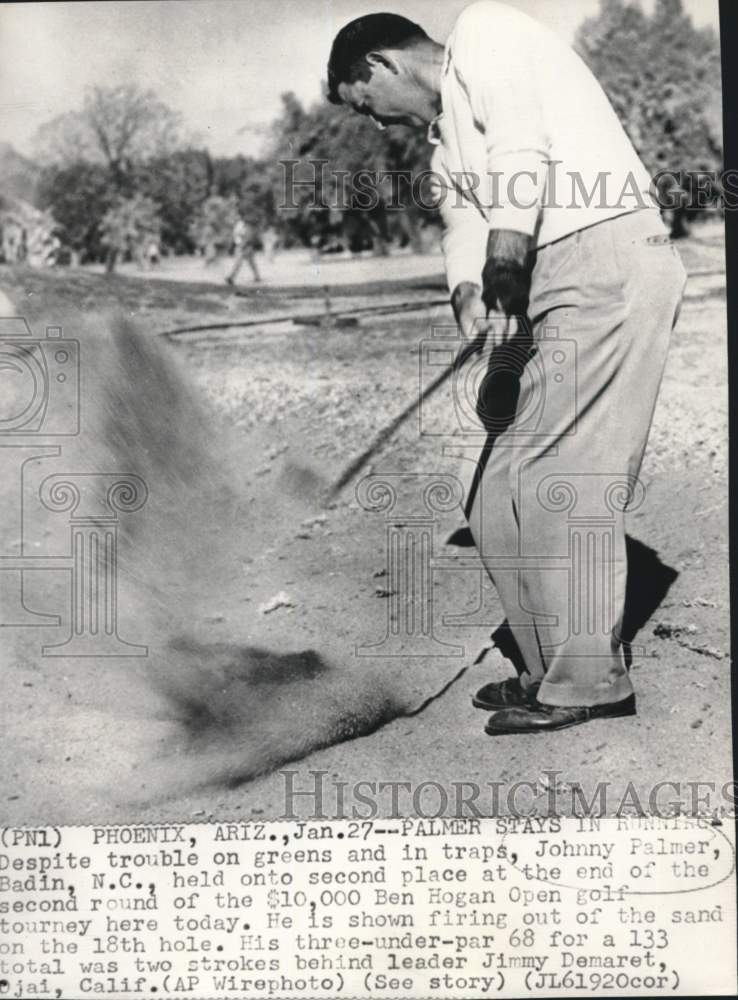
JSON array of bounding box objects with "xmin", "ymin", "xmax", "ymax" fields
[{"xmin": 328, "ymin": 2, "xmax": 685, "ymax": 735}]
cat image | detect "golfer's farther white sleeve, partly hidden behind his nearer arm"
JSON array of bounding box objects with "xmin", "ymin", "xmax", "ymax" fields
[{"xmin": 431, "ymin": 149, "xmax": 489, "ymax": 292}]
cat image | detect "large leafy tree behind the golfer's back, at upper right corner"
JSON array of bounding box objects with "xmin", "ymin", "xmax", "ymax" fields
[{"xmin": 576, "ymin": 0, "xmax": 722, "ymax": 235}]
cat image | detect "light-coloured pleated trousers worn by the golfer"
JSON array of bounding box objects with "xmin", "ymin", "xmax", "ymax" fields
[{"xmin": 467, "ymin": 210, "xmax": 686, "ymax": 706}]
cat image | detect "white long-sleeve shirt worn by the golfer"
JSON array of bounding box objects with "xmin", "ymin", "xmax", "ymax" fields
[{"xmin": 429, "ymin": 0, "xmax": 655, "ymax": 291}]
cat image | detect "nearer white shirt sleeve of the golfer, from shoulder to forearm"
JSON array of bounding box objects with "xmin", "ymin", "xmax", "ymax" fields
[{"xmin": 452, "ymin": 2, "xmax": 550, "ymax": 236}]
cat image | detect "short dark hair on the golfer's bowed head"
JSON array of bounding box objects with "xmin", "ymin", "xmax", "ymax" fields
[{"xmin": 328, "ymin": 14, "xmax": 428, "ymax": 104}]
